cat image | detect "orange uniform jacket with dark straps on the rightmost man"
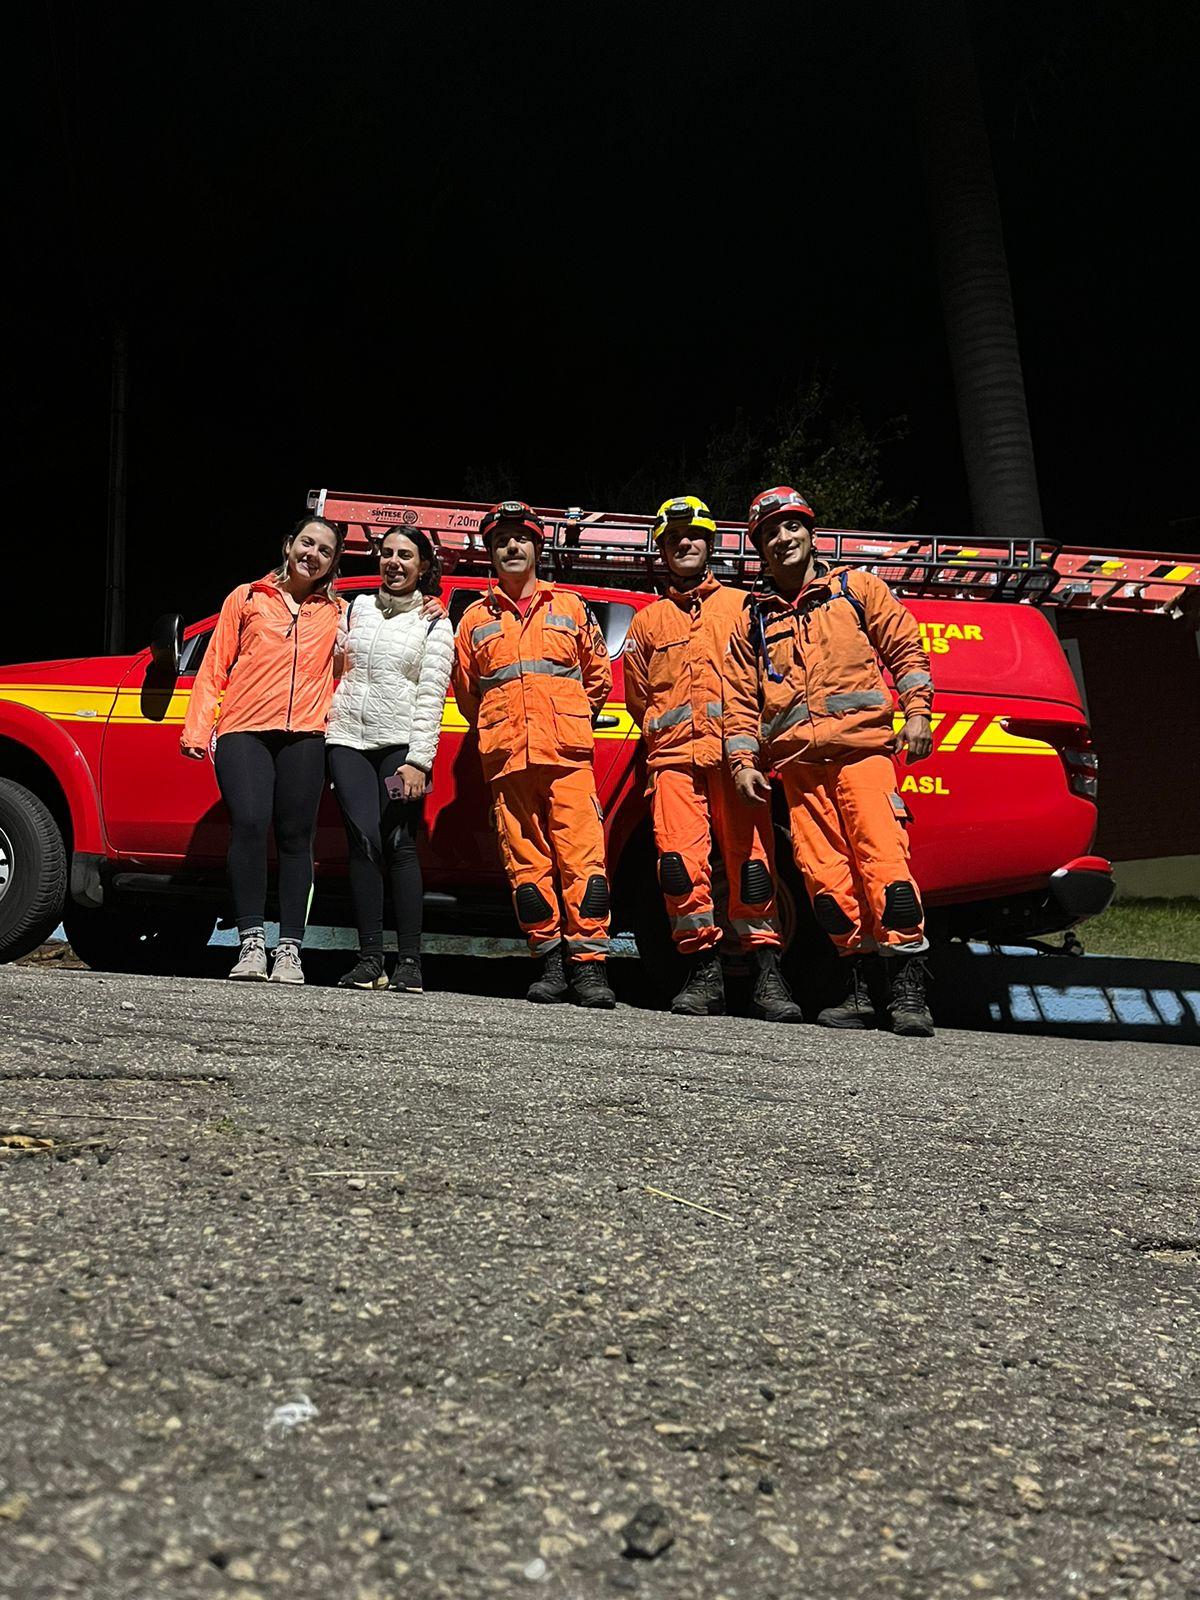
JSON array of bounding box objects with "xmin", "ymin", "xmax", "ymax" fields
[{"xmin": 725, "ymin": 566, "xmax": 933, "ymax": 771}]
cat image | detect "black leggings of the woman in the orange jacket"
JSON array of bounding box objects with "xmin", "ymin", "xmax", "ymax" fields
[{"xmin": 214, "ymin": 731, "xmax": 325, "ymax": 939}]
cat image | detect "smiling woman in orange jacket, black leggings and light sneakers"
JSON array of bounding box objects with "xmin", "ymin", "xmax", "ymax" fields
[{"xmin": 179, "ymin": 517, "xmax": 346, "ymax": 984}]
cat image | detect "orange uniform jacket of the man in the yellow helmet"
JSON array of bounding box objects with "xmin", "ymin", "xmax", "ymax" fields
[{"xmin": 622, "ymin": 573, "xmax": 749, "ymax": 771}]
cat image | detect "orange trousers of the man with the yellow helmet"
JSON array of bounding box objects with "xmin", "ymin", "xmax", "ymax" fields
[{"xmin": 650, "ymin": 766, "xmax": 781, "ymax": 955}]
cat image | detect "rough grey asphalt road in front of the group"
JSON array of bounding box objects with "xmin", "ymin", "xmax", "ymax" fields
[{"xmin": 0, "ymin": 968, "xmax": 1200, "ymax": 1600}]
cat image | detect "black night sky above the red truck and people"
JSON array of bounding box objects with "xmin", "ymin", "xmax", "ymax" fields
[{"xmin": 11, "ymin": 0, "xmax": 1200, "ymax": 661}]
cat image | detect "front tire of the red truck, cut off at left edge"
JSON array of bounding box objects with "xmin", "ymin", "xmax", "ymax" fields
[{"xmin": 0, "ymin": 778, "xmax": 67, "ymax": 962}]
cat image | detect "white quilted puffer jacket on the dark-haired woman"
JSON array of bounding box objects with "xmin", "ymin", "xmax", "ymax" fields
[{"xmin": 325, "ymin": 594, "xmax": 454, "ymax": 773}]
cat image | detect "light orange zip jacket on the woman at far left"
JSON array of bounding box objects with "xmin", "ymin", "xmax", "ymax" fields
[{"xmin": 179, "ymin": 576, "xmax": 342, "ymax": 749}]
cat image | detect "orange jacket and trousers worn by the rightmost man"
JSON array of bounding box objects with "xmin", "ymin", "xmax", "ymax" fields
[{"xmin": 725, "ymin": 566, "xmax": 933, "ymax": 955}]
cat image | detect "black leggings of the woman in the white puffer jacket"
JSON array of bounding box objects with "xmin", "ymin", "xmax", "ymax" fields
[{"xmin": 330, "ymin": 744, "xmax": 426, "ymax": 957}]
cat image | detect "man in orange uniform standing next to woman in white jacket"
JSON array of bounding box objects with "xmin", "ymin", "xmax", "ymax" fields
[{"xmin": 453, "ymin": 501, "xmax": 616, "ymax": 1008}]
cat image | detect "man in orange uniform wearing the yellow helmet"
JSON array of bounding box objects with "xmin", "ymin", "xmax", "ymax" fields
[{"xmin": 622, "ymin": 494, "xmax": 803, "ymax": 1022}]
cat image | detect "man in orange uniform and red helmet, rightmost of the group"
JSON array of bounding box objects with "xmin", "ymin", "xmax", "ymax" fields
[{"xmin": 725, "ymin": 486, "xmax": 933, "ymax": 1037}]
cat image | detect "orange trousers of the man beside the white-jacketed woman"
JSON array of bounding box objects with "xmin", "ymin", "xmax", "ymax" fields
[{"xmin": 491, "ymin": 766, "xmax": 608, "ymax": 962}]
